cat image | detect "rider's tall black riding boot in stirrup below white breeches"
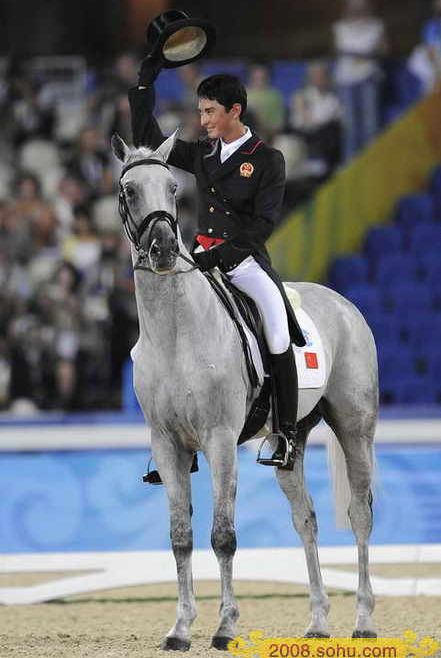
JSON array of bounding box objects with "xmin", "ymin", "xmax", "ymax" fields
[{"xmin": 270, "ymin": 345, "xmax": 299, "ymax": 470}]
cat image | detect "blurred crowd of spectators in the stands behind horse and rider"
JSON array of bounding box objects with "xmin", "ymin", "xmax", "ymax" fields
[{"xmin": 0, "ymin": 0, "xmax": 441, "ymax": 412}]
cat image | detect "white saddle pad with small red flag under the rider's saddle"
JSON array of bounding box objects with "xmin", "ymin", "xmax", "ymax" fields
[{"xmin": 242, "ymin": 295, "xmax": 326, "ymax": 388}]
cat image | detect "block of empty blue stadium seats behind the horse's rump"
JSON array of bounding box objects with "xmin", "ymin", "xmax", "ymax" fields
[{"xmin": 329, "ymin": 165, "xmax": 441, "ymax": 404}]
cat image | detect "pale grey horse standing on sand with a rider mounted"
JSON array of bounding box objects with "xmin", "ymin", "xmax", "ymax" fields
[{"xmin": 112, "ymin": 133, "xmax": 378, "ymax": 651}]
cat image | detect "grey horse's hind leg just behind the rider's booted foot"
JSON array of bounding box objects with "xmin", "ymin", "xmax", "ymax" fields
[{"xmin": 276, "ymin": 429, "xmax": 329, "ymax": 637}]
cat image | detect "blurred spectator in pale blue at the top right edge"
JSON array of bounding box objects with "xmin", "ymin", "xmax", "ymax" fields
[{"xmin": 409, "ymin": 0, "xmax": 441, "ymax": 93}]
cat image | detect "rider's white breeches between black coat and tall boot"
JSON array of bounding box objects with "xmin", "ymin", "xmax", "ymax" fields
[{"xmin": 227, "ymin": 256, "xmax": 291, "ymax": 354}]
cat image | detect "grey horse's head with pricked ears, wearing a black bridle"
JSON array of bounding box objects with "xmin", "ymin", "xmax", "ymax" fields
[{"xmin": 112, "ymin": 131, "xmax": 179, "ymax": 274}]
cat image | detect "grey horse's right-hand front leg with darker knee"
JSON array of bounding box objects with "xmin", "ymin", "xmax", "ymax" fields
[{"xmin": 205, "ymin": 434, "xmax": 239, "ymax": 650}]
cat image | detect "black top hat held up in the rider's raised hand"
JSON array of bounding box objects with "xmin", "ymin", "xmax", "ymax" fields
[{"xmin": 146, "ymin": 9, "xmax": 216, "ymax": 68}]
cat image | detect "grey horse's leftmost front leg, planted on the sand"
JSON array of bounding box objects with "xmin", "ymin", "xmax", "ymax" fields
[{"xmin": 152, "ymin": 431, "xmax": 196, "ymax": 651}]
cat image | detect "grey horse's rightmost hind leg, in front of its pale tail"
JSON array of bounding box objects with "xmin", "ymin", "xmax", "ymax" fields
[{"xmin": 323, "ymin": 400, "xmax": 377, "ymax": 637}]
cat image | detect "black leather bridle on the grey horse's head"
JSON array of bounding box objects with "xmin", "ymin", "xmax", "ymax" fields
[{"xmin": 118, "ymin": 158, "xmax": 199, "ymax": 274}]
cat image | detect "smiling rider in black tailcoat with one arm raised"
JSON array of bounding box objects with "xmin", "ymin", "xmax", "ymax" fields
[{"xmin": 129, "ymin": 56, "xmax": 305, "ymax": 468}]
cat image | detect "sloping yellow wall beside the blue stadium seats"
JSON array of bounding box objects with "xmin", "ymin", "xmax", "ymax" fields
[{"xmin": 269, "ymin": 91, "xmax": 441, "ymax": 281}]
